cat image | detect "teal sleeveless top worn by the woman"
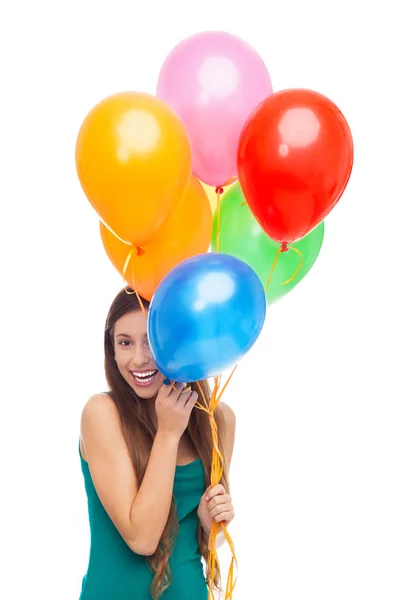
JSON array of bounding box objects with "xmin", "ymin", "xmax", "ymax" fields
[{"xmin": 79, "ymin": 438, "xmax": 208, "ymax": 600}]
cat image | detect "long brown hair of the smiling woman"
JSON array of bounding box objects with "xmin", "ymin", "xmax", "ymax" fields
[{"xmin": 104, "ymin": 287, "xmax": 229, "ymax": 600}]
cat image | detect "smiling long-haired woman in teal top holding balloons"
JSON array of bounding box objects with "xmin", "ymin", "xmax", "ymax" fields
[{"xmin": 79, "ymin": 288, "xmax": 235, "ymax": 600}]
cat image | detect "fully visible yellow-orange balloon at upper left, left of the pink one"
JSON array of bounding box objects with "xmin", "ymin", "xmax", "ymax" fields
[{"xmin": 75, "ymin": 92, "xmax": 191, "ymax": 246}]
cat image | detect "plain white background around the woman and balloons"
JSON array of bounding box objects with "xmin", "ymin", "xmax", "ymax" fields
[{"xmin": 0, "ymin": 0, "xmax": 400, "ymax": 600}]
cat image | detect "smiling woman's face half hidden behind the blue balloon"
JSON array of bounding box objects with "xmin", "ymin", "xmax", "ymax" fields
[{"xmin": 114, "ymin": 310, "xmax": 164, "ymax": 398}]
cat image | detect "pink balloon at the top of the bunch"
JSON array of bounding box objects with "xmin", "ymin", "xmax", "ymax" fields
[{"xmin": 157, "ymin": 31, "xmax": 272, "ymax": 186}]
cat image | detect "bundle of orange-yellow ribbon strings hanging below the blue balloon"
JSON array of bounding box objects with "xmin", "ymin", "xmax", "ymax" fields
[{"xmin": 195, "ymin": 365, "xmax": 238, "ymax": 600}]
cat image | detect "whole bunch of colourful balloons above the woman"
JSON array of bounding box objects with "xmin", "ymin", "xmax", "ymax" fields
[{"xmin": 76, "ymin": 31, "xmax": 353, "ymax": 381}]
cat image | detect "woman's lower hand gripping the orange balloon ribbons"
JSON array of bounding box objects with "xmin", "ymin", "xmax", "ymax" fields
[{"xmin": 197, "ymin": 483, "xmax": 235, "ymax": 535}]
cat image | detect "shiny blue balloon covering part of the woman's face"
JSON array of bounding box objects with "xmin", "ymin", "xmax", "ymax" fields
[{"xmin": 148, "ymin": 252, "xmax": 266, "ymax": 383}]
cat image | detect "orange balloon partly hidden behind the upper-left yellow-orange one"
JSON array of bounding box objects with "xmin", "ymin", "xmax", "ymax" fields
[{"xmin": 100, "ymin": 176, "xmax": 212, "ymax": 301}]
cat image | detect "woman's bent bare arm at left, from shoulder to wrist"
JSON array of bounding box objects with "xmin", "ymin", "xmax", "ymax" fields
[{"xmin": 81, "ymin": 394, "xmax": 179, "ymax": 556}]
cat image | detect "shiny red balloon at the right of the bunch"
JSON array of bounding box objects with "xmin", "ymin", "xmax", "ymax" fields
[{"xmin": 238, "ymin": 89, "xmax": 354, "ymax": 244}]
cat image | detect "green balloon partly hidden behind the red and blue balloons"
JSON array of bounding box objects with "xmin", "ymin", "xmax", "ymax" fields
[{"xmin": 211, "ymin": 183, "xmax": 324, "ymax": 304}]
